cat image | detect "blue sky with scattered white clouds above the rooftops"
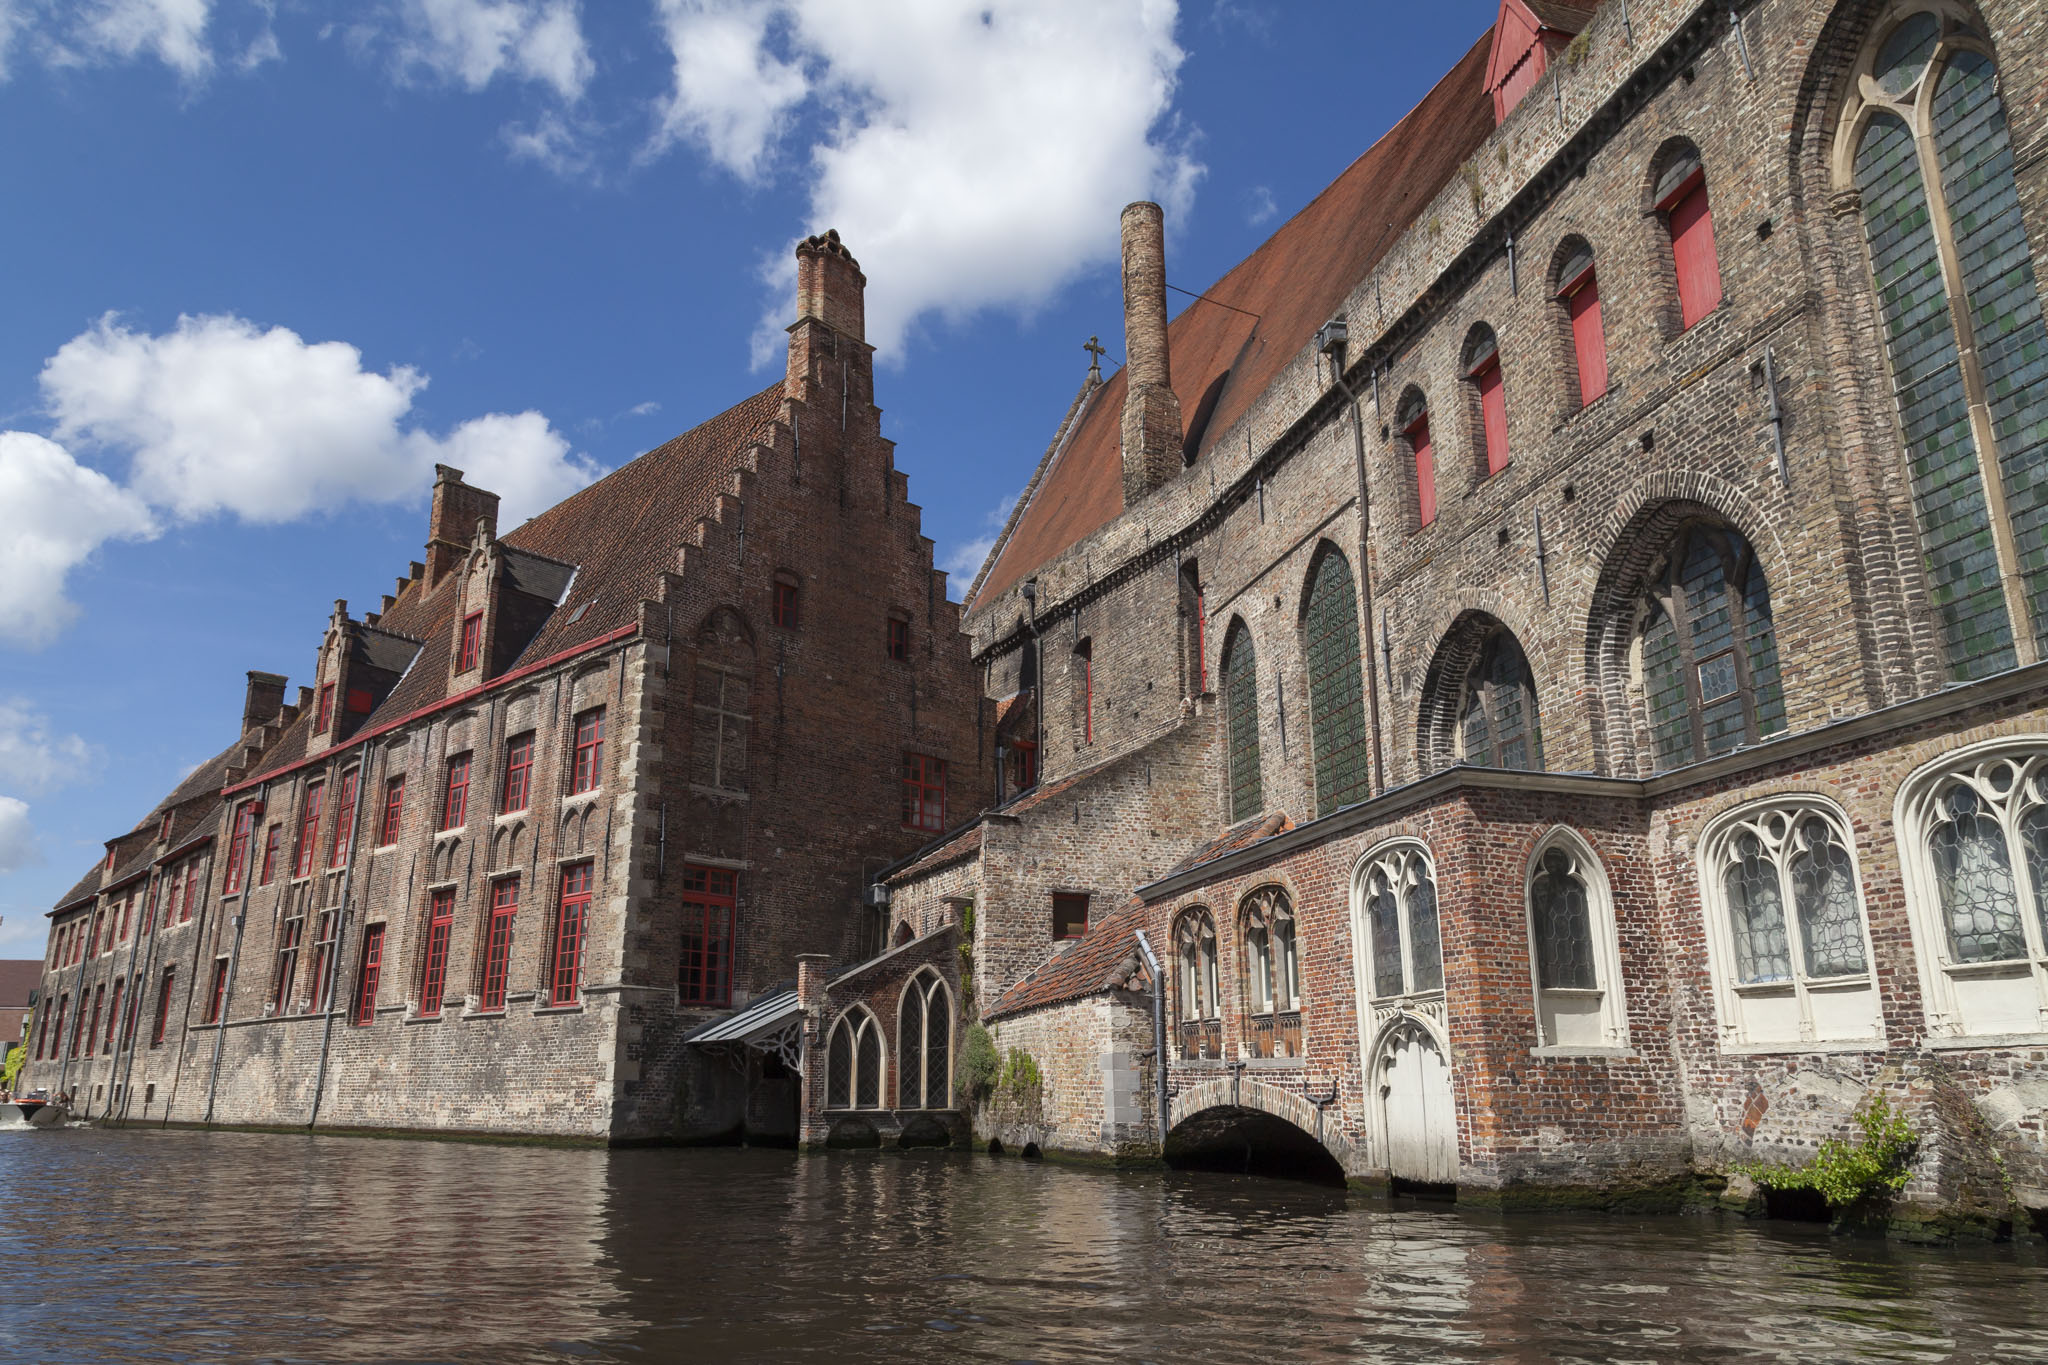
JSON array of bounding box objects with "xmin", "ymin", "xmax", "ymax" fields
[{"xmin": 0, "ymin": 0, "xmax": 1495, "ymax": 956}]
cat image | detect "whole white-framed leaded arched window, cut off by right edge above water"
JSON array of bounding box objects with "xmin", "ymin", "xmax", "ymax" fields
[{"xmin": 1894, "ymin": 737, "xmax": 2048, "ymax": 1038}]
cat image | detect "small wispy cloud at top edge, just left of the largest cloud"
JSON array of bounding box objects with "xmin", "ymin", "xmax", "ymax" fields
[{"xmin": 397, "ymin": 0, "xmax": 596, "ymax": 100}]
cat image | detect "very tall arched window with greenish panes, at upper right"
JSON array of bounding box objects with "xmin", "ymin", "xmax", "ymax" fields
[{"xmin": 1835, "ymin": 4, "xmax": 2048, "ymax": 679}]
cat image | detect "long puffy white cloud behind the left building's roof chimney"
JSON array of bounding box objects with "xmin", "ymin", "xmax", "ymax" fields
[{"xmin": 43, "ymin": 315, "xmax": 600, "ymax": 526}]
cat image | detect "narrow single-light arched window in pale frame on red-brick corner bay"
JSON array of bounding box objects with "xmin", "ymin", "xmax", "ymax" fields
[{"xmin": 1528, "ymin": 827, "xmax": 1628, "ymax": 1052}]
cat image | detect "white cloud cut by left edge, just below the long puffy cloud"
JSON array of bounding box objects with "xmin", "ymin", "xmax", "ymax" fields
[{"xmin": 0, "ymin": 432, "xmax": 156, "ymax": 647}]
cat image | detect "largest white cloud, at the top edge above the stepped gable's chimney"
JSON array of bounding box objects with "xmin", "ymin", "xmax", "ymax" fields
[{"xmin": 649, "ymin": 0, "xmax": 1202, "ymax": 362}]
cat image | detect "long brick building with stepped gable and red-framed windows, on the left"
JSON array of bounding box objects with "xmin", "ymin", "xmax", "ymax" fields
[{"xmin": 23, "ymin": 233, "xmax": 993, "ymax": 1142}]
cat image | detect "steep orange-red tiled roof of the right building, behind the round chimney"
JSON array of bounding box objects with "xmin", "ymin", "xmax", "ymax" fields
[{"xmin": 975, "ymin": 29, "xmax": 1493, "ymax": 604}]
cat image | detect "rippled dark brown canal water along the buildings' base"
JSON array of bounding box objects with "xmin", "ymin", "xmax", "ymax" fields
[{"xmin": 0, "ymin": 1128, "xmax": 2048, "ymax": 1363}]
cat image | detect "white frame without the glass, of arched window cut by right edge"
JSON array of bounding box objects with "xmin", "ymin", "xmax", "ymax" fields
[{"xmin": 1892, "ymin": 735, "xmax": 2048, "ymax": 1048}]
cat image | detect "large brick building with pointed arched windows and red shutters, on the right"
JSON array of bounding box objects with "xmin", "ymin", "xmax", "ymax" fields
[{"xmin": 868, "ymin": 0, "xmax": 2048, "ymax": 1224}]
